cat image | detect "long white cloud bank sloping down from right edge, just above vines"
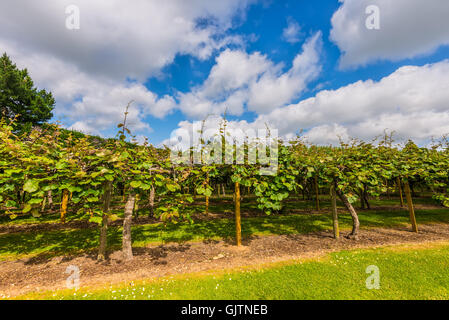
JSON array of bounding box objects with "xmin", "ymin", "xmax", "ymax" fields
[{"xmin": 252, "ymin": 60, "xmax": 449, "ymax": 143}]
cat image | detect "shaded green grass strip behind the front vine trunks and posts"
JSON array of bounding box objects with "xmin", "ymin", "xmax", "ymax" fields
[{"xmin": 0, "ymin": 208, "xmax": 449, "ymax": 260}]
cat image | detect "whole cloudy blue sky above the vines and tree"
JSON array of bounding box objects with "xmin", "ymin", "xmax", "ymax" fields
[{"xmin": 0, "ymin": 0, "xmax": 449, "ymax": 145}]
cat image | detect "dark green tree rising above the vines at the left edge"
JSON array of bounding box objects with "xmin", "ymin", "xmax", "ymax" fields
[{"xmin": 0, "ymin": 53, "xmax": 55, "ymax": 129}]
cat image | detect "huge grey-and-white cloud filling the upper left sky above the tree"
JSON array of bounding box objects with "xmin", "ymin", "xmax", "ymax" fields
[{"xmin": 0, "ymin": 0, "xmax": 253, "ymax": 134}]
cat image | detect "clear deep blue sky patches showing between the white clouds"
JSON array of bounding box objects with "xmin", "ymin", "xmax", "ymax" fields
[{"xmin": 146, "ymin": 0, "xmax": 342, "ymax": 141}]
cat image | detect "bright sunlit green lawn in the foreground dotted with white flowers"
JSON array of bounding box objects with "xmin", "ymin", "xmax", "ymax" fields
[{"xmin": 20, "ymin": 242, "xmax": 449, "ymax": 300}]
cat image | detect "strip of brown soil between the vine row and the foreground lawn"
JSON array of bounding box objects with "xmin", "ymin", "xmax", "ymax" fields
[{"xmin": 0, "ymin": 224, "xmax": 449, "ymax": 298}]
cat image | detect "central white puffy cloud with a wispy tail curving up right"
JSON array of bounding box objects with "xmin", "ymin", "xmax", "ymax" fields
[{"xmin": 179, "ymin": 32, "xmax": 322, "ymax": 118}]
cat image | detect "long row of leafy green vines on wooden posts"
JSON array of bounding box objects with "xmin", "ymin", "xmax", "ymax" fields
[{"xmin": 0, "ymin": 117, "xmax": 449, "ymax": 260}]
